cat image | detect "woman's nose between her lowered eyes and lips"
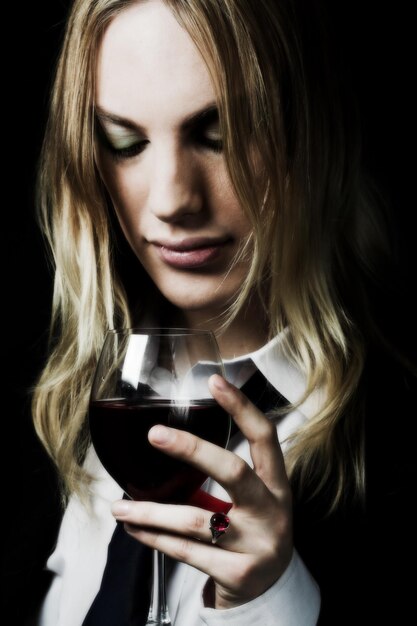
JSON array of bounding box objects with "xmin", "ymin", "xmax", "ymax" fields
[{"xmin": 148, "ymin": 145, "xmax": 203, "ymax": 223}]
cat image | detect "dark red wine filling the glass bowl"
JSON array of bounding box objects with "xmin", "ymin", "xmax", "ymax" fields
[{"xmin": 89, "ymin": 400, "xmax": 230, "ymax": 504}]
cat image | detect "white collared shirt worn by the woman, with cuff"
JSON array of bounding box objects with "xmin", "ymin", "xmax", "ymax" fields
[{"xmin": 39, "ymin": 334, "xmax": 321, "ymax": 626}]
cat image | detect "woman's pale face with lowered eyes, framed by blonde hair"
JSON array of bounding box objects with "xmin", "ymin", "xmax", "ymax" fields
[{"xmin": 96, "ymin": 0, "xmax": 250, "ymax": 316}]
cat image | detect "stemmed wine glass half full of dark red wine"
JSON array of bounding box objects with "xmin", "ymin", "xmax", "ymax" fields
[{"xmin": 89, "ymin": 328, "xmax": 231, "ymax": 626}]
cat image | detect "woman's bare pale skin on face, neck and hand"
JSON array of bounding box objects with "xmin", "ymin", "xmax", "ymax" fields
[{"xmin": 96, "ymin": 0, "xmax": 292, "ymax": 609}]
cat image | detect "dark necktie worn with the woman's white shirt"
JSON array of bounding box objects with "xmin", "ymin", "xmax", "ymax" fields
[{"xmin": 83, "ymin": 369, "xmax": 287, "ymax": 626}]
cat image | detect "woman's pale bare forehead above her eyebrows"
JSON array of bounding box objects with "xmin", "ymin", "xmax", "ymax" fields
[{"xmin": 96, "ymin": 0, "xmax": 215, "ymax": 124}]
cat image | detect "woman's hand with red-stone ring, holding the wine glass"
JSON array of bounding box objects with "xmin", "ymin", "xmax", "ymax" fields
[{"xmin": 113, "ymin": 375, "xmax": 292, "ymax": 609}]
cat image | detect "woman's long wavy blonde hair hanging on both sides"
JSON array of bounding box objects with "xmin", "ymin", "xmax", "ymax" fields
[{"xmin": 33, "ymin": 0, "xmax": 392, "ymax": 506}]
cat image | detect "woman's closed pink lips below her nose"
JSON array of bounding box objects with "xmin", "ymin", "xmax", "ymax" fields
[{"xmin": 152, "ymin": 238, "xmax": 226, "ymax": 269}]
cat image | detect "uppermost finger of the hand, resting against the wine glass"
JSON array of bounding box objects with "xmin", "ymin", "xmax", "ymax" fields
[{"xmin": 210, "ymin": 374, "xmax": 287, "ymax": 491}]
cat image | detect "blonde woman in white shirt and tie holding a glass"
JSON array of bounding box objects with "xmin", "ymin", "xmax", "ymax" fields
[{"xmin": 8, "ymin": 0, "xmax": 415, "ymax": 626}]
